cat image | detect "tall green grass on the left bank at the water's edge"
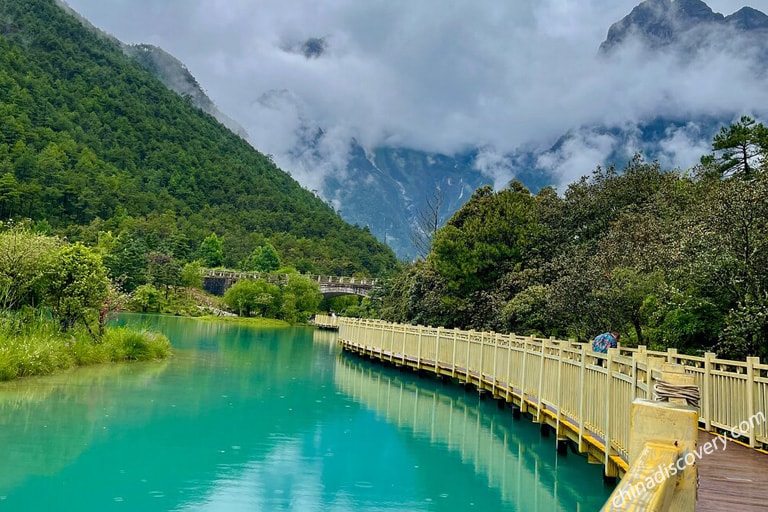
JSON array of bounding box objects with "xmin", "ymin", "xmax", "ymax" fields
[{"xmin": 0, "ymin": 312, "xmax": 171, "ymax": 381}]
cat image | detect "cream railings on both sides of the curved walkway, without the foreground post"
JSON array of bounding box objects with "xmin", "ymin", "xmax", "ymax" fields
[{"xmin": 332, "ymin": 318, "xmax": 768, "ymax": 510}]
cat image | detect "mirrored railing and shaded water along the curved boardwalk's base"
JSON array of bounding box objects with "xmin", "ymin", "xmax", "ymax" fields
[{"xmin": 335, "ymin": 354, "xmax": 608, "ymax": 510}]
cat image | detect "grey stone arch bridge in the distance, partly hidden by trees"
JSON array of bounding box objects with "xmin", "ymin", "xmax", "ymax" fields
[{"xmin": 202, "ymin": 269, "xmax": 377, "ymax": 297}]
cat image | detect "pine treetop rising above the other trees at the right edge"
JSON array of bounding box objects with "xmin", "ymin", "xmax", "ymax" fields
[{"xmin": 701, "ymin": 116, "xmax": 768, "ymax": 179}]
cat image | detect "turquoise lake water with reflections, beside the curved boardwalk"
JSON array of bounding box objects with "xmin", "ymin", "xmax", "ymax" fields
[{"xmin": 0, "ymin": 315, "xmax": 611, "ymax": 512}]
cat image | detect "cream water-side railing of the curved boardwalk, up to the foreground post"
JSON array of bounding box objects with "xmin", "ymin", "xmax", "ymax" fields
[{"xmin": 339, "ymin": 318, "xmax": 652, "ymax": 477}]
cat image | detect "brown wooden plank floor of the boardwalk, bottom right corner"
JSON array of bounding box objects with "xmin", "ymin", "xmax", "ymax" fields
[{"xmin": 696, "ymin": 431, "xmax": 768, "ymax": 512}]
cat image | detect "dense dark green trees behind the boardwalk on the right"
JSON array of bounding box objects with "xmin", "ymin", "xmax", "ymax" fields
[{"xmin": 374, "ymin": 141, "xmax": 768, "ymax": 358}]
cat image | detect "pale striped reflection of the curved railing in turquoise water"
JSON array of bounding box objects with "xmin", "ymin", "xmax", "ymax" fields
[{"xmin": 335, "ymin": 356, "xmax": 600, "ymax": 510}]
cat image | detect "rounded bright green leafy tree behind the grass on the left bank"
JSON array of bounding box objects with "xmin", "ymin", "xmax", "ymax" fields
[{"xmin": 46, "ymin": 242, "xmax": 109, "ymax": 334}]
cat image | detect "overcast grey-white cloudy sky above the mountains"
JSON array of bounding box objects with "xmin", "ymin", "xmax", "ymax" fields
[{"xmin": 67, "ymin": 0, "xmax": 768, "ymax": 189}]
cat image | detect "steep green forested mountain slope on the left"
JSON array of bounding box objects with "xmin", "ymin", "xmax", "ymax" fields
[{"xmin": 0, "ymin": 0, "xmax": 396, "ymax": 275}]
